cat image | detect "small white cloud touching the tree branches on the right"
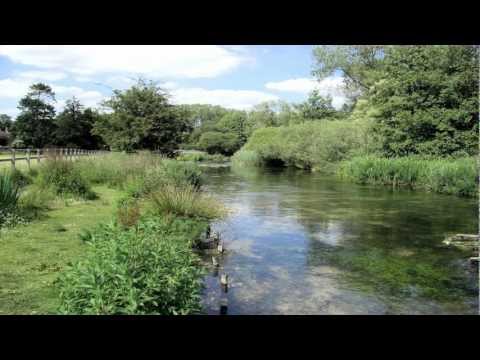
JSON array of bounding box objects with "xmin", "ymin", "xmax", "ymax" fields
[{"xmin": 265, "ymin": 76, "xmax": 347, "ymax": 109}]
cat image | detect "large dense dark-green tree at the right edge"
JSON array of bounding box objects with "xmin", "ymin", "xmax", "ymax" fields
[{"xmin": 371, "ymin": 45, "xmax": 479, "ymax": 156}]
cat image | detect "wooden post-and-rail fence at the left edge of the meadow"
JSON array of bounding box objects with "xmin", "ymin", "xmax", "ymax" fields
[{"xmin": 0, "ymin": 147, "xmax": 110, "ymax": 169}]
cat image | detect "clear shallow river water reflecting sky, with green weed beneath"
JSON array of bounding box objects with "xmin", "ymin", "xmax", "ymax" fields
[{"xmin": 198, "ymin": 166, "xmax": 478, "ymax": 314}]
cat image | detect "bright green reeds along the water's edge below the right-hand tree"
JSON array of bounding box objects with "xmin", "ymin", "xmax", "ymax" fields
[{"xmin": 338, "ymin": 156, "xmax": 478, "ymax": 197}]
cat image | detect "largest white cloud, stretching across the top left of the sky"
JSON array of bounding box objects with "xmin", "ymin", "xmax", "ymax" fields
[{"xmin": 0, "ymin": 45, "xmax": 249, "ymax": 78}]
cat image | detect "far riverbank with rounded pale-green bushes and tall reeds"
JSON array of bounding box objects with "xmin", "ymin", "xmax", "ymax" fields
[{"xmin": 232, "ymin": 120, "xmax": 478, "ymax": 197}]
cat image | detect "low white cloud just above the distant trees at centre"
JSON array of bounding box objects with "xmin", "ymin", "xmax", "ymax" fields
[{"xmin": 171, "ymin": 88, "xmax": 279, "ymax": 110}]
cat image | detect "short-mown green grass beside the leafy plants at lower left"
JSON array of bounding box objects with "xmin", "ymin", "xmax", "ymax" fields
[{"xmin": 0, "ymin": 186, "xmax": 123, "ymax": 314}]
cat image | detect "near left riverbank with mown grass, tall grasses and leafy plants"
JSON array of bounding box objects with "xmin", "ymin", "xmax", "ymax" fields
[{"xmin": 0, "ymin": 154, "xmax": 224, "ymax": 314}]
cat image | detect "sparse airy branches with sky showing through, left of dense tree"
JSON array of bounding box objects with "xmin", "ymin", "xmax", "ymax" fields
[{"xmin": 313, "ymin": 45, "xmax": 385, "ymax": 98}]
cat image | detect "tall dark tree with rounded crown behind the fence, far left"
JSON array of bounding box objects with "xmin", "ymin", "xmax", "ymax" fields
[{"xmin": 12, "ymin": 83, "xmax": 55, "ymax": 148}]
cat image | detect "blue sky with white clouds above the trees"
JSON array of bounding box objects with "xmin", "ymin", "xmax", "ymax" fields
[{"xmin": 0, "ymin": 45, "xmax": 345, "ymax": 117}]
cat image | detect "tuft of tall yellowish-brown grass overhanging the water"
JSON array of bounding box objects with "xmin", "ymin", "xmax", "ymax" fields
[{"xmin": 150, "ymin": 185, "xmax": 226, "ymax": 219}]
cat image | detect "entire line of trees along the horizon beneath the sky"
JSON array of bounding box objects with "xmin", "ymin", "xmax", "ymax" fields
[{"xmin": 0, "ymin": 45, "xmax": 479, "ymax": 156}]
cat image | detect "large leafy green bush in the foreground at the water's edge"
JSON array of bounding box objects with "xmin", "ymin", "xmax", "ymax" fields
[{"xmin": 58, "ymin": 218, "xmax": 202, "ymax": 315}]
